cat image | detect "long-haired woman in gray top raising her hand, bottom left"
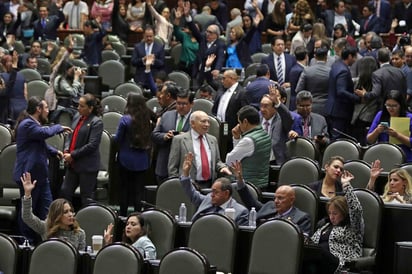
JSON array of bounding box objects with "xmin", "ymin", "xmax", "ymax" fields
[{"xmin": 20, "ymin": 172, "xmax": 86, "ymax": 251}]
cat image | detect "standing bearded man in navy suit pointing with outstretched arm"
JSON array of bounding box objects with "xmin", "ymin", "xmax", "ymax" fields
[{"xmin": 13, "ymin": 97, "xmax": 72, "ymax": 244}]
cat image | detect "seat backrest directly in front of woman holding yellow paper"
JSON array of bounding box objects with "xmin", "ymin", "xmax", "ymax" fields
[{"xmin": 363, "ymin": 143, "xmax": 406, "ymax": 172}]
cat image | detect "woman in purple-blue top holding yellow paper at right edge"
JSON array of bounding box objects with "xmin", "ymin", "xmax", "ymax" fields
[{"xmin": 366, "ymin": 90, "xmax": 412, "ymax": 162}]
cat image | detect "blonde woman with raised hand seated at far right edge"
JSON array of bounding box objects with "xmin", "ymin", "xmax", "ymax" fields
[{"xmin": 366, "ymin": 160, "xmax": 412, "ymax": 204}]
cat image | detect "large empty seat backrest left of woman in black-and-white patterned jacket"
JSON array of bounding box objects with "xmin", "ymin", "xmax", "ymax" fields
[{"xmin": 247, "ymin": 219, "xmax": 303, "ymax": 274}]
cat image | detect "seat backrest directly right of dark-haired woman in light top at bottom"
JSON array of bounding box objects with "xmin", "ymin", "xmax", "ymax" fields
[{"xmin": 142, "ymin": 208, "xmax": 176, "ymax": 259}]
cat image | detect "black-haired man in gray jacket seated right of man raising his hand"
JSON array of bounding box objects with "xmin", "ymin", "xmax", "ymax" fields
[{"xmin": 290, "ymin": 90, "xmax": 330, "ymax": 148}]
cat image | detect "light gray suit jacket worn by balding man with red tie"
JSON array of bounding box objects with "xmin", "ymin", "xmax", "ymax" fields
[{"xmin": 168, "ymin": 131, "xmax": 226, "ymax": 181}]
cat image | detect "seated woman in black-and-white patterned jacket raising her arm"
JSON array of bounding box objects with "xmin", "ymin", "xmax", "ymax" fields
[{"xmin": 311, "ymin": 171, "xmax": 364, "ymax": 273}]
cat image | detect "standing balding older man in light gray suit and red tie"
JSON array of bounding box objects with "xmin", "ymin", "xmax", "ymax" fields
[{"xmin": 168, "ymin": 111, "xmax": 232, "ymax": 188}]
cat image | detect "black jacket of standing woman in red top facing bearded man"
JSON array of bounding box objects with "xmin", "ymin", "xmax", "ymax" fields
[{"xmin": 65, "ymin": 113, "xmax": 103, "ymax": 172}]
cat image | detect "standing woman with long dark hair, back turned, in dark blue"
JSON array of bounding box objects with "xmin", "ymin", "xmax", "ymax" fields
[{"xmin": 115, "ymin": 93, "xmax": 155, "ymax": 216}]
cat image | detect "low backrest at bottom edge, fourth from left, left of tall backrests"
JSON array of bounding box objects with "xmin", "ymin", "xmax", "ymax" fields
[{"xmin": 159, "ymin": 247, "xmax": 210, "ymax": 274}]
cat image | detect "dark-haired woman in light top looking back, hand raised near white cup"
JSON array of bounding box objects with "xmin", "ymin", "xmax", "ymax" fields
[{"xmin": 104, "ymin": 212, "xmax": 156, "ymax": 260}]
